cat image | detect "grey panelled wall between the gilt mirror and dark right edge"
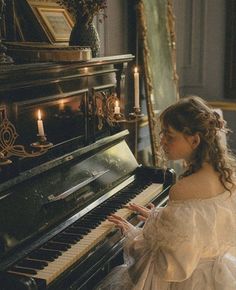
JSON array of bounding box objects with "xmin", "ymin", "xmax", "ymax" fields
[{"xmin": 173, "ymin": 0, "xmax": 225, "ymax": 100}]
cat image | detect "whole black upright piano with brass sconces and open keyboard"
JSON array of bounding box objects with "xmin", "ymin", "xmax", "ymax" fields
[{"xmin": 0, "ymin": 55, "xmax": 175, "ymax": 290}]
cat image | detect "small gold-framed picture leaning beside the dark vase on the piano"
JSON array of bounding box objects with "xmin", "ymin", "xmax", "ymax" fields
[{"xmin": 35, "ymin": 6, "xmax": 74, "ymax": 43}]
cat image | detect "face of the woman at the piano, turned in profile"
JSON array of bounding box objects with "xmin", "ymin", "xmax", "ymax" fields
[{"xmin": 161, "ymin": 126, "xmax": 200, "ymax": 162}]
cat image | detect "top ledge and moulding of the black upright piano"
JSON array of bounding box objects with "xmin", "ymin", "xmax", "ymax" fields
[{"xmin": 0, "ymin": 54, "xmax": 134, "ymax": 92}]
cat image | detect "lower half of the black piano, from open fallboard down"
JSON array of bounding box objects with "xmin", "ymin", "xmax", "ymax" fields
[{"xmin": 0, "ymin": 131, "xmax": 174, "ymax": 290}]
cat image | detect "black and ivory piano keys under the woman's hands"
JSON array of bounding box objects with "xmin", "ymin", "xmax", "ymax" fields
[{"xmin": 8, "ymin": 183, "xmax": 163, "ymax": 285}]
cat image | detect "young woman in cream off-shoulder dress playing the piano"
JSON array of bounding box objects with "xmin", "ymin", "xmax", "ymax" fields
[{"xmin": 96, "ymin": 97, "xmax": 236, "ymax": 290}]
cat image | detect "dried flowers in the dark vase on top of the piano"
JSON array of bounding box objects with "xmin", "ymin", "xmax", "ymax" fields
[{"xmin": 57, "ymin": 0, "xmax": 107, "ymax": 24}]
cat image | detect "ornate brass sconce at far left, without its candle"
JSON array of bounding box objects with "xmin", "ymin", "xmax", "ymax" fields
[{"xmin": 0, "ymin": 117, "xmax": 53, "ymax": 166}]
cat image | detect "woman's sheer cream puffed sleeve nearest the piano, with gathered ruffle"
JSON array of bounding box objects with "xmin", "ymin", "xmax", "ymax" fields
[{"xmin": 125, "ymin": 205, "xmax": 202, "ymax": 282}]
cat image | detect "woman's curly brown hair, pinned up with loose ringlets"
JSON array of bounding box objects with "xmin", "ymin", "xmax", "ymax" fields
[{"xmin": 160, "ymin": 96, "xmax": 235, "ymax": 191}]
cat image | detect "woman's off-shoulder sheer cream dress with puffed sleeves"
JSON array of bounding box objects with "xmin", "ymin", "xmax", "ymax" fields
[{"xmin": 96, "ymin": 191, "xmax": 236, "ymax": 290}]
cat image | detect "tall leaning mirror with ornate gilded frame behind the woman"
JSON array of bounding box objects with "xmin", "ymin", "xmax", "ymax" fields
[{"xmin": 137, "ymin": 0, "xmax": 178, "ymax": 166}]
